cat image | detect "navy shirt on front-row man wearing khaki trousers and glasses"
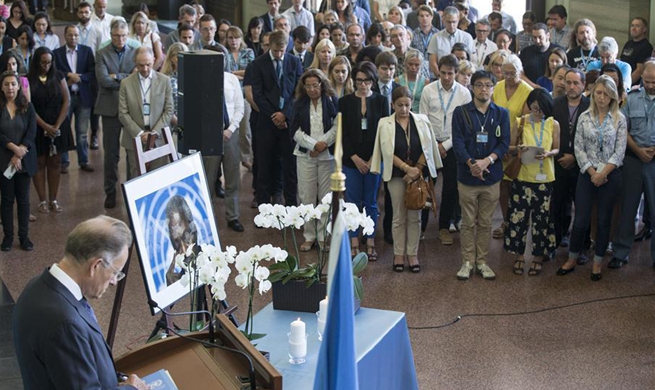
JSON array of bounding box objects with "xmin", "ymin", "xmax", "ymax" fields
[{"xmin": 453, "ymin": 102, "xmax": 510, "ymax": 186}]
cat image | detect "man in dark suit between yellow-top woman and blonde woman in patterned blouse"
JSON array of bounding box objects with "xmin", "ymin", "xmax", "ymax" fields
[{"xmin": 550, "ymin": 68, "xmax": 589, "ymax": 264}]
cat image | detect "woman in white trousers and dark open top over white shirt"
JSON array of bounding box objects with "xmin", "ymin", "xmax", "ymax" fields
[{"xmin": 289, "ymin": 69, "xmax": 339, "ymax": 252}]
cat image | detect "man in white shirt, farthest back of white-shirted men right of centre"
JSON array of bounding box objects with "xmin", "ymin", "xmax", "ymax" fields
[{"xmin": 428, "ymin": 6, "xmax": 475, "ymax": 75}]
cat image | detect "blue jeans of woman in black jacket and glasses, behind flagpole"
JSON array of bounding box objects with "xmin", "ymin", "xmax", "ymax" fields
[{"xmin": 343, "ymin": 165, "xmax": 381, "ymax": 238}]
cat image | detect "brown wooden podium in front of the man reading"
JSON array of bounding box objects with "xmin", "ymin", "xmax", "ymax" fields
[{"xmin": 115, "ymin": 314, "xmax": 282, "ymax": 390}]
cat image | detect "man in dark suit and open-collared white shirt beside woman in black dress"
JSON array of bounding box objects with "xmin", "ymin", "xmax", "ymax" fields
[{"xmin": 53, "ymin": 24, "xmax": 96, "ymax": 172}]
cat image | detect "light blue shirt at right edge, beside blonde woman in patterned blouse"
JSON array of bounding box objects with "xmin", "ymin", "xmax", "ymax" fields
[{"xmin": 623, "ymin": 87, "xmax": 655, "ymax": 148}]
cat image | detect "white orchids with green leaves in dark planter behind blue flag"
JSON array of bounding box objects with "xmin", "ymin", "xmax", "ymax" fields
[{"xmin": 255, "ymin": 193, "xmax": 375, "ymax": 299}]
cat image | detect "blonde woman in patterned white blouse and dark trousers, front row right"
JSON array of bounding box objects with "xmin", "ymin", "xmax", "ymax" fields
[{"xmin": 557, "ymin": 75, "xmax": 627, "ymax": 282}]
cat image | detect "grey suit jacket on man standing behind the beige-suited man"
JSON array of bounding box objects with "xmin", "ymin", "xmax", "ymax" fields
[{"xmin": 94, "ymin": 44, "xmax": 136, "ymax": 116}]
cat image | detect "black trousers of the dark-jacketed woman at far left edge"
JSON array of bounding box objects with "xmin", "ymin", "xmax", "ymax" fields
[{"xmin": 0, "ymin": 173, "xmax": 31, "ymax": 239}]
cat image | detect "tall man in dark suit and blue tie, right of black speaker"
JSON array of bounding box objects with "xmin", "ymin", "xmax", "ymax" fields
[{"xmin": 251, "ymin": 30, "xmax": 302, "ymax": 206}]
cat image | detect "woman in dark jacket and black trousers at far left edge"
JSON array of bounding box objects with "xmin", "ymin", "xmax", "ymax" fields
[{"xmin": 0, "ymin": 71, "xmax": 36, "ymax": 252}]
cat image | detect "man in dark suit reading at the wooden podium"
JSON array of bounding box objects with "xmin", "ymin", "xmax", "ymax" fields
[{"xmin": 12, "ymin": 216, "xmax": 148, "ymax": 390}]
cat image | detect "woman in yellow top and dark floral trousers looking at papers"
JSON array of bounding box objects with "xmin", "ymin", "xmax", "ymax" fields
[{"xmin": 504, "ymin": 88, "xmax": 559, "ymax": 276}]
